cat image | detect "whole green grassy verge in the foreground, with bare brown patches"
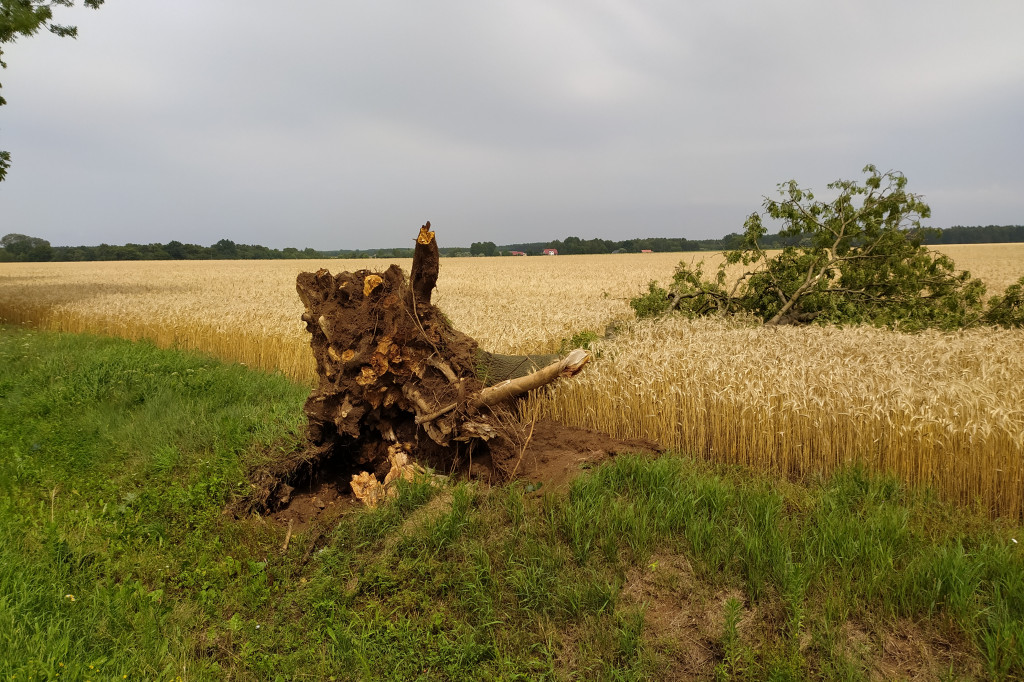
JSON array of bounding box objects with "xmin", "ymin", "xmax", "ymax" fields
[{"xmin": 0, "ymin": 327, "xmax": 1024, "ymax": 680}]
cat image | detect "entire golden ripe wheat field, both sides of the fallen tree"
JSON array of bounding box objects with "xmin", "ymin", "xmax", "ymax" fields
[{"xmin": 6, "ymin": 244, "xmax": 1024, "ymax": 518}]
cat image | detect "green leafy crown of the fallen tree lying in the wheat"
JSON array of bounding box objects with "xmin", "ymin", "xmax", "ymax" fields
[{"xmin": 630, "ymin": 165, "xmax": 1024, "ymax": 331}]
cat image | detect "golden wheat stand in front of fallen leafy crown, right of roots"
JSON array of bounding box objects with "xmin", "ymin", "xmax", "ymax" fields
[{"xmin": 526, "ymin": 318, "xmax": 1024, "ymax": 517}]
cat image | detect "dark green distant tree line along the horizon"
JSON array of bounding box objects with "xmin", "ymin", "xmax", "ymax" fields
[{"xmin": 6, "ymin": 225, "xmax": 1024, "ymax": 262}]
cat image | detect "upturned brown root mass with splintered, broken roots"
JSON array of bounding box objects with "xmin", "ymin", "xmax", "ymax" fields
[{"xmin": 296, "ymin": 222, "xmax": 590, "ymax": 479}]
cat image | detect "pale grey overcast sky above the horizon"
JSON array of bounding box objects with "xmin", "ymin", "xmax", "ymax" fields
[{"xmin": 0, "ymin": 0, "xmax": 1024, "ymax": 249}]
